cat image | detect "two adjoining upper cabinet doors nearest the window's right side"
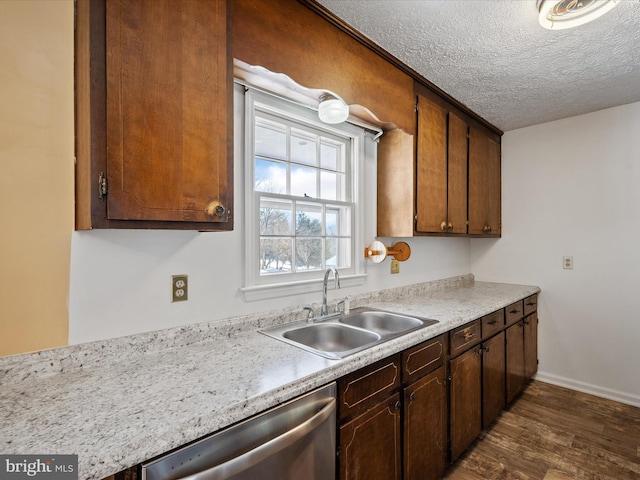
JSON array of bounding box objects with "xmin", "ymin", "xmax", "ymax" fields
[{"xmin": 415, "ymin": 95, "xmax": 467, "ymax": 234}]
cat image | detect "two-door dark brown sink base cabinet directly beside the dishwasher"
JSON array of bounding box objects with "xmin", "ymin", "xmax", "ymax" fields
[{"xmin": 338, "ymin": 335, "xmax": 447, "ymax": 480}]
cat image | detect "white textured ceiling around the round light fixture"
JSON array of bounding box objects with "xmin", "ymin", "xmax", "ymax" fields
[{"xmin": 318, "ymin": 0, "xmax": 640, "ymax": 131}]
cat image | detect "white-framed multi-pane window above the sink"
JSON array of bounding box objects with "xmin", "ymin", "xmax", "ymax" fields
[{"xmin": 243, "ymin": 85, "xmax": 365, "ymax": 299}]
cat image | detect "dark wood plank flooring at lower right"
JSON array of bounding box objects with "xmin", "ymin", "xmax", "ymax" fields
[{"xmin": 444, "ymin": 381, "xmax": 640, "ymax": 480}]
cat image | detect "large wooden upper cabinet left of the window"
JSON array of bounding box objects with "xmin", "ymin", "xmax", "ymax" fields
[{"xmin": 76, "ymin": 0, "xmax": 233, "ymax": 230}]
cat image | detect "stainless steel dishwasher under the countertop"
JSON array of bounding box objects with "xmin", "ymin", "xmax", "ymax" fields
[{"xmin": 142, "ymin": 383, "xmax": 336, "ymax": 480}]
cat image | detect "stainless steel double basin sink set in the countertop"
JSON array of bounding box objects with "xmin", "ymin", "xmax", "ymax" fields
[{"xmin": 261, "ymin": 307, "xmax": 438, "ymax": 359}]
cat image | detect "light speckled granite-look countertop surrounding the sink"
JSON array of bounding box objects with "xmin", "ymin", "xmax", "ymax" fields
[{"xmin": 0, "ymin": 275, "xmax": 540, "ymax": 479}]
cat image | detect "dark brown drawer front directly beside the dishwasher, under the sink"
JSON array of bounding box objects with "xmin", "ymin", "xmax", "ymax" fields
[{"xmin": 338, "ymin": 354, "xmax": 400, "ymax": 418}]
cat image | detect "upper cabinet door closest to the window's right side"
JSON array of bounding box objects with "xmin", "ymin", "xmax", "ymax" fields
[{"xmin": 416, "ymin": 95, "xmax": 447, "ymax": 232}]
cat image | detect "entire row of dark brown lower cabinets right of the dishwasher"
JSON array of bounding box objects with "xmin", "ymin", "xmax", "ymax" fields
[{"xmin": 338, "ymin": 301, "xmax": 538, "ymax": 480}]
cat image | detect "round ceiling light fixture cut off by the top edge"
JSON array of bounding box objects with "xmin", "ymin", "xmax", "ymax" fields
[{"xmin": 537, "ymin": 0, "xmax": 620, "ymax": 30}]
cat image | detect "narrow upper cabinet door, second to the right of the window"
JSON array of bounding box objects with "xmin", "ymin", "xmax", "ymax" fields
[{"xmin": 447, "ymin": 112, "xmax": 468, "ymax": 234}]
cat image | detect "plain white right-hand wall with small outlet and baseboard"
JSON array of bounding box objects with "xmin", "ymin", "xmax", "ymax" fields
[{"xmin": 471, "ymin": 103, "xmax": 640, "ymax": 405}]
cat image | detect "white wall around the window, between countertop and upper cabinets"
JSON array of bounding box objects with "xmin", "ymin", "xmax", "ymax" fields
[{"xmin": 69, "ymin": 89, "xmax": 471, "ymax": 344}]
